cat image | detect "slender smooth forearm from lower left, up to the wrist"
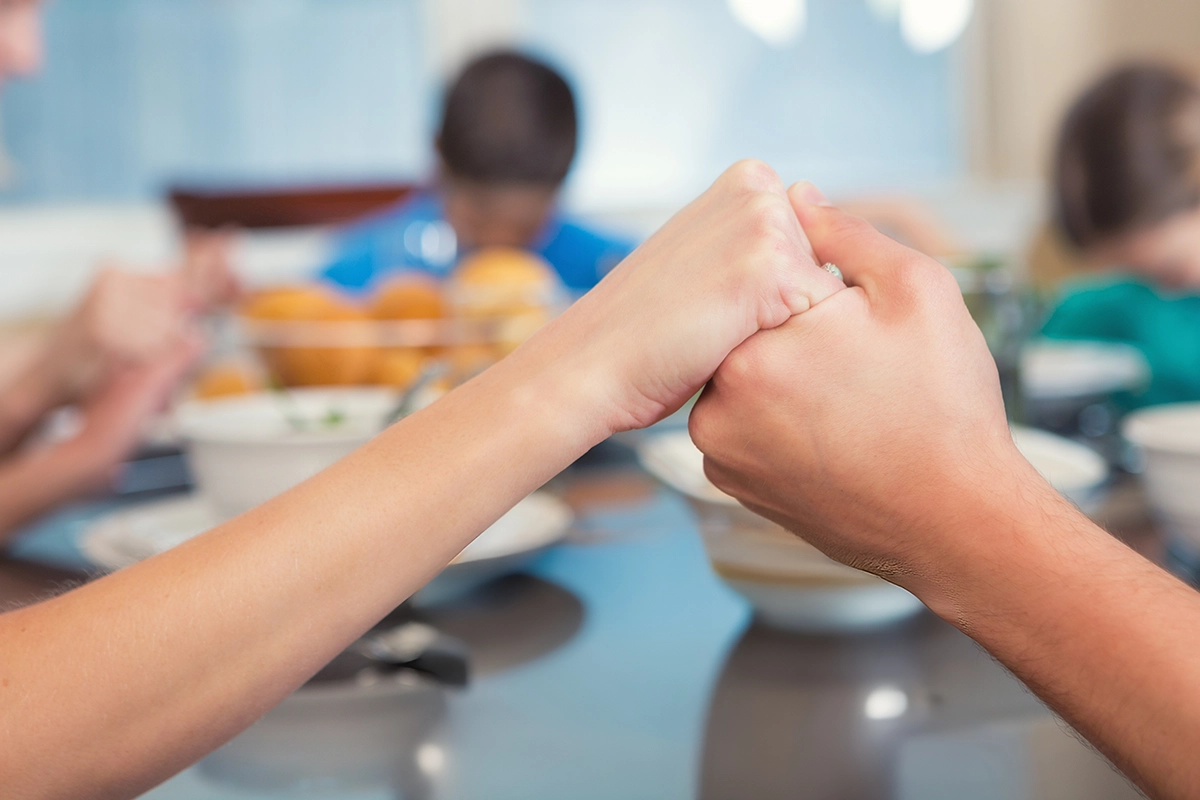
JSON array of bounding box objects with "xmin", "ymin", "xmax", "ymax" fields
[{"xmin": 0, "ymin": 351, "xmax": 604, "ymax": 798}]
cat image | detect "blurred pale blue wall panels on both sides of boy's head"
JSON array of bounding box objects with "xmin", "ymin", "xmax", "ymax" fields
[{"xmin": 0, "ymin": 0, "xmax": 962, "ymax": 203}]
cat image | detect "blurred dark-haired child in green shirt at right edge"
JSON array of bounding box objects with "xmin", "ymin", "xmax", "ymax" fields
[{"xmin": 1042, "ymin": 65, "xmax": 1200, "ymax": 407}]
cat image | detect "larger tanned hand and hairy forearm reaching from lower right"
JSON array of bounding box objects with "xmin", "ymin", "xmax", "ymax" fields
[{"xmin": 691, "ymin": 186, "xmax": 1200, "ymax": 798}]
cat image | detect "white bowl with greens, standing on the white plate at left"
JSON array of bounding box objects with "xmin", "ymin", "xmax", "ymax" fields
[{"xmin": 176, "ymin": 389, "xmax": 397, "ymax": 517}]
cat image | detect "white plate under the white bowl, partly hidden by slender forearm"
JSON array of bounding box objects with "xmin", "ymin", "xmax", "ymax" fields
[{"xmin": 78, "ymin": 492, "xmax": 574, "ymax": 577}]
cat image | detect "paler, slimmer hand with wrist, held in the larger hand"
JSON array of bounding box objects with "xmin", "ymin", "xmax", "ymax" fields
[{"xmin": 530, "ymin": 161, "xmax": 845, "ymax": 433}]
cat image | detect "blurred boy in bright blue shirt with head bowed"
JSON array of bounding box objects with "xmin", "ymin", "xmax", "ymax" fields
[{"xmin": 323, "ymin": 52, "xmax": 632, "ymax": 293}]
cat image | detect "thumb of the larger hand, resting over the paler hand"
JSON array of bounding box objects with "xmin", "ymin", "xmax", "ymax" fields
[{"xmin": 788, "ymin": 192, "xmax": 946, "ymax": 299}]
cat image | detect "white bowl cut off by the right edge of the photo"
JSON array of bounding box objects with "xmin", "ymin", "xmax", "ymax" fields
[{"xmin": 1123, "ymin": 403, "xmax": 1200, "ymax": 554}]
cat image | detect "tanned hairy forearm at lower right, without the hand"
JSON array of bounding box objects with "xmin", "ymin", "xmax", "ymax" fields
[{"xmin": 947, "ymin": 482, "xmax": 1200, "ymax": 798}]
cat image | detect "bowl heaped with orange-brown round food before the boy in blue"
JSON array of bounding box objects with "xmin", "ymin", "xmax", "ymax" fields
[{"xmin": 239, "ymin": 248, "xmax": 565, "ymax": 389}]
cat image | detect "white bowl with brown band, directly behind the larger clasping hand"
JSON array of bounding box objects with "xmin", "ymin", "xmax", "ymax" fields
[{"xmin": 638, "ymin": 428, "xmax": 1108, "ymax": 632}]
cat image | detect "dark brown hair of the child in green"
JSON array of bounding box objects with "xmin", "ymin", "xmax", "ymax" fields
[{"xmin": 1054, "ymin": 65, "xmax": 1200, "ymax": 247}]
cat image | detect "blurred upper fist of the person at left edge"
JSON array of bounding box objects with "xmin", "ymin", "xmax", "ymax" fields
[{"xmin": 46, "ymin": 267, "xmax": 192, "ymax": 402}]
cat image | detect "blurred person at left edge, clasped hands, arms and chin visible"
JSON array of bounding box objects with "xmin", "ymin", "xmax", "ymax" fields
[{"xmin": 0, "ymin": 0, "xmax": 238, "ymax": 543}]
